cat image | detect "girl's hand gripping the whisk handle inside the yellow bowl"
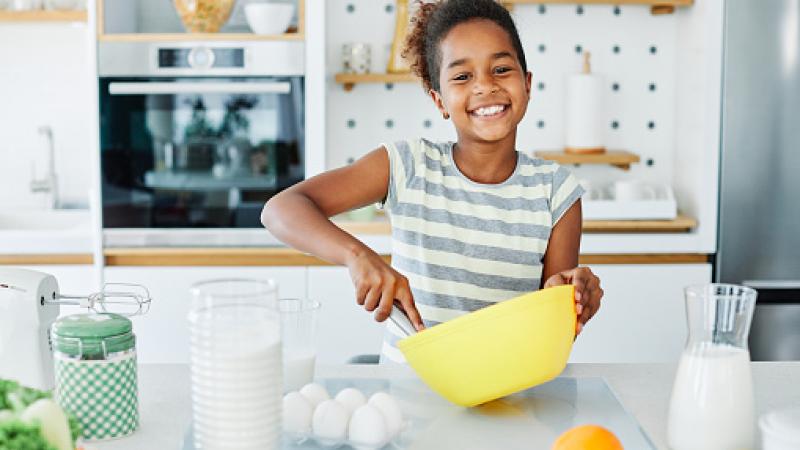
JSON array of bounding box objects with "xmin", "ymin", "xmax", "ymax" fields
[{"xmin": 347, "ymin": 249, "xmax": 425, "ymax": 331}]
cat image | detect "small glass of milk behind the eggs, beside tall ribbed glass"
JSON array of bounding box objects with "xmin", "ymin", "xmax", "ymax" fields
[{"xmin": 278, "ymin": 298, "xmax": 320, "ymax": 392}]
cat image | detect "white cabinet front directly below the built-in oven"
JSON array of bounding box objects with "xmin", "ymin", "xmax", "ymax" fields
[{"xmin": 105, "ymin": 267, "xmax": 306, "ymax": 363}]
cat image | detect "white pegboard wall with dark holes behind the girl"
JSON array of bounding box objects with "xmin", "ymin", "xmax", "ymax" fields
[{"xmin": 326, "ymin": 0, "xmax": 690, "ymax": 182}]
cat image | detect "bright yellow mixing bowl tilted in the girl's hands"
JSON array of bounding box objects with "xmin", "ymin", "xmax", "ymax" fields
[{"xmin": 398, "ymin": 285, "xmax": 576, "ymax": 406}]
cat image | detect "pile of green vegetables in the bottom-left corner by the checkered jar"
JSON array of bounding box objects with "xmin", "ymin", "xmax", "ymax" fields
[{"xmin": 0, "ymin": 379, "xmax": 81, "ymax": 450}]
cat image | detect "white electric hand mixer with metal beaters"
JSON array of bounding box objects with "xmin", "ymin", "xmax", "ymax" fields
[{"xmin": 0, "ymin": 268, "xmax": 151, "ymax": 390}]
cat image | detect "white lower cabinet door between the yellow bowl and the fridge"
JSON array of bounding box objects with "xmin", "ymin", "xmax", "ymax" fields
[{"xmin": 570, "ymin": 264, "xmax": 711, "ymax": 363}]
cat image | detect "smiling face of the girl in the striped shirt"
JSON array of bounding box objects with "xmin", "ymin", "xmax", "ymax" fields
[{"xmin": 430, "ymin": 20, "xmax": 531, "ymax": 142}]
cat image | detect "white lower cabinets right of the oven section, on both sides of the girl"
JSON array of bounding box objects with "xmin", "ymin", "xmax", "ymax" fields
[{"xmin": 308, "ymin": 264, "xmax": 711, "ymax": 364}]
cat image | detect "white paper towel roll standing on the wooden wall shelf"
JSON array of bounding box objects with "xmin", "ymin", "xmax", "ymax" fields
[{"xmin": 565, "ymin": 73, "xmax": 605, "ymax": 153}]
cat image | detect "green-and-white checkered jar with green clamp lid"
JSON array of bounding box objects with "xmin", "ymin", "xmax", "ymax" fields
[{"xmin": 50, "ymin": 313, "xmax": 139, "ymax": 441}]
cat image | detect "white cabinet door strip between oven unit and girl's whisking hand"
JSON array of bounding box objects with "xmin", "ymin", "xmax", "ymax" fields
[{"xmin": 308, "ymin": 267, "xmax": 383, "ymax": 364}]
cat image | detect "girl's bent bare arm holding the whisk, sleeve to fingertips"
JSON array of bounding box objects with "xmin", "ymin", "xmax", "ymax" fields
[{"xmin": 261, "ymin": 147, "xmax": 423, "ymax": 329}]
